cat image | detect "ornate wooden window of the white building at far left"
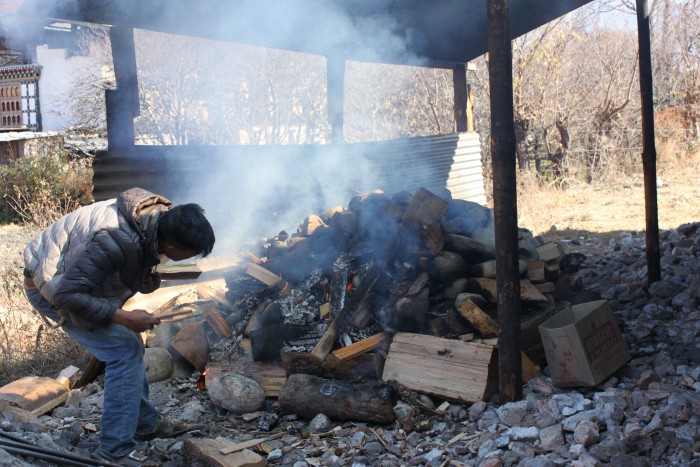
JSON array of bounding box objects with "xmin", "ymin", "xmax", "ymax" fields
[{"xmin": 0, "ymin": 65, "xmax": 41, "ymax": 131}]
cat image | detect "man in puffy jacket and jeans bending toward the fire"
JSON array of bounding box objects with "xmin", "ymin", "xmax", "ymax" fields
[{"xmin": 24, "ymin": 188, "xmax": 215, "ymax": 464}]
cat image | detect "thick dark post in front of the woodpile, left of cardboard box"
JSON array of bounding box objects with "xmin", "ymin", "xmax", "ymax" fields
[{"xmin": 486, "ymin": 0, "xmax": 523, "ymax": 402}]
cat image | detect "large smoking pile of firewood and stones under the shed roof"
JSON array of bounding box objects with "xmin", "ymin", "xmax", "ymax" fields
[{"xmin": 172, "ymin": 189, "xmax": 566, "ymax": 422}]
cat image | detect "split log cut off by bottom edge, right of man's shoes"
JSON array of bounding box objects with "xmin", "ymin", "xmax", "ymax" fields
[{"xmin": 182, "ymin": 437, "xmax": 267, "ymax": 467}]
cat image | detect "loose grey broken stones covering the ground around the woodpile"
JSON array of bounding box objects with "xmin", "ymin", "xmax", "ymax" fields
[{"xmin": 0, "ymin": 223, "xmax": 700, "ymax": 467}]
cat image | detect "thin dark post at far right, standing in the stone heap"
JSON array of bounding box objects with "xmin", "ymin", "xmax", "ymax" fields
[{"xmin": 637, "ymin": 0, "xmax": 661, "ymax": 284}]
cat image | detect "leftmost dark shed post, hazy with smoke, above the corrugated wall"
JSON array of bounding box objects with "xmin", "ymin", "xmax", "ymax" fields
[{"xmin": 105, "ymin": 26, "xmax": 139, "ymax": 150}]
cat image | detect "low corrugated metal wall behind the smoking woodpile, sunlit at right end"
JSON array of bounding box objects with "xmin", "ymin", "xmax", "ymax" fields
[{"xmin": 94, "ymin": 132, "xmax": 485, "ymax": 204}]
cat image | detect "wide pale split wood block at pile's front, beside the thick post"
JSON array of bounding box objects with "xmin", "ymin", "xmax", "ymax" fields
[{"xmin": 382, "ymin": 332, "xmax": 493, "ymax": 402}]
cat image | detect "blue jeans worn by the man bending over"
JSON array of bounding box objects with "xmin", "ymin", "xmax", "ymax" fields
[{"xmin": 25, "ymin": 289, "xmax": 160, "ymax": 457}]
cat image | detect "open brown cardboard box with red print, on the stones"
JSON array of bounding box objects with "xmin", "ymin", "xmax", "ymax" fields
[{"xmin": 539, "ymin": 300, "xmax": 630, "ymax": 386}]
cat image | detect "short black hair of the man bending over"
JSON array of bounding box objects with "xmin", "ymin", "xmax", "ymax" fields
[{"xmin": 158, "ymin": 203, "xmax": 216, "ymax": 257}]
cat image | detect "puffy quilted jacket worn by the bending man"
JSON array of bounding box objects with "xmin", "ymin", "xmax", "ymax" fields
[{"xmin": 24, "ymin": 188, "xmax": 172, "ymax": 329}]
